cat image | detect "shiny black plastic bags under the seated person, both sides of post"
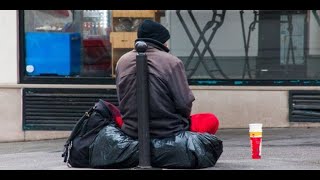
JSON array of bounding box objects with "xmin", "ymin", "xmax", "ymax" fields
[{"xmin": 90, "ymin": 124, "xmax": 223, "ymax": 169}]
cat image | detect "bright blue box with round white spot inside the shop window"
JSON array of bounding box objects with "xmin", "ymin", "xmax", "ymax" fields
[{"xmin": 25, "ymin": 32, "xmax": 81, "ymax": 76}]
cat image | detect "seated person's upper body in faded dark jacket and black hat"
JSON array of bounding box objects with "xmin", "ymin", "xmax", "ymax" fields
[{"xmin": 116, "ymin": 21, "xmax": 195, "ymax": 137}]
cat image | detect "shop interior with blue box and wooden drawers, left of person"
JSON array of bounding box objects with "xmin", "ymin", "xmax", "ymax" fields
[{"xmin": 24, "ymin": 10, "xmax": 159, "ymax": 78}]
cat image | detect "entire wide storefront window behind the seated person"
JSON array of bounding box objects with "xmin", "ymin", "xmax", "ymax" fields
[{"xmin": 21, "ymin": 10, "xmax": 320, "ymax": 85}]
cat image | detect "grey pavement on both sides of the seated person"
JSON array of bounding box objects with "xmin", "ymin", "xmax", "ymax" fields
[{"xmin": 0, "ymin": 128, "xmax": 320, "ymax": 170}]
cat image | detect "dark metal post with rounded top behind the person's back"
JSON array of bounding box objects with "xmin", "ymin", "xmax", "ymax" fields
[{"xmin": 135, "ymin": 41, "xmax": 151, "ymax": 168}]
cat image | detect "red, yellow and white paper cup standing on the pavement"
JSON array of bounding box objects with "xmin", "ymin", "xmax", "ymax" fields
[{"xmin": 249, "ymin": 123, "xmax": 262, "ymax": 159}]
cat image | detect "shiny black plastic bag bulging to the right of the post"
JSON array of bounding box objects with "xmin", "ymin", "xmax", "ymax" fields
[{"xmin": 151, "ymin": 131, "xmax": 223, "ymax": 169}]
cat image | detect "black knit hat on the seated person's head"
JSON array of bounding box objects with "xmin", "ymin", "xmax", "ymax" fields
[{"xmin": 138, "ymin": 19, "xmax": 170, "ymax": 44}]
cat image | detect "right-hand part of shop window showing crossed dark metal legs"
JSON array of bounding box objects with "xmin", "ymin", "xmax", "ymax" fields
[{"xmin": 166, "ymin": 10, "xmax": 320, "ymax": 80}]
